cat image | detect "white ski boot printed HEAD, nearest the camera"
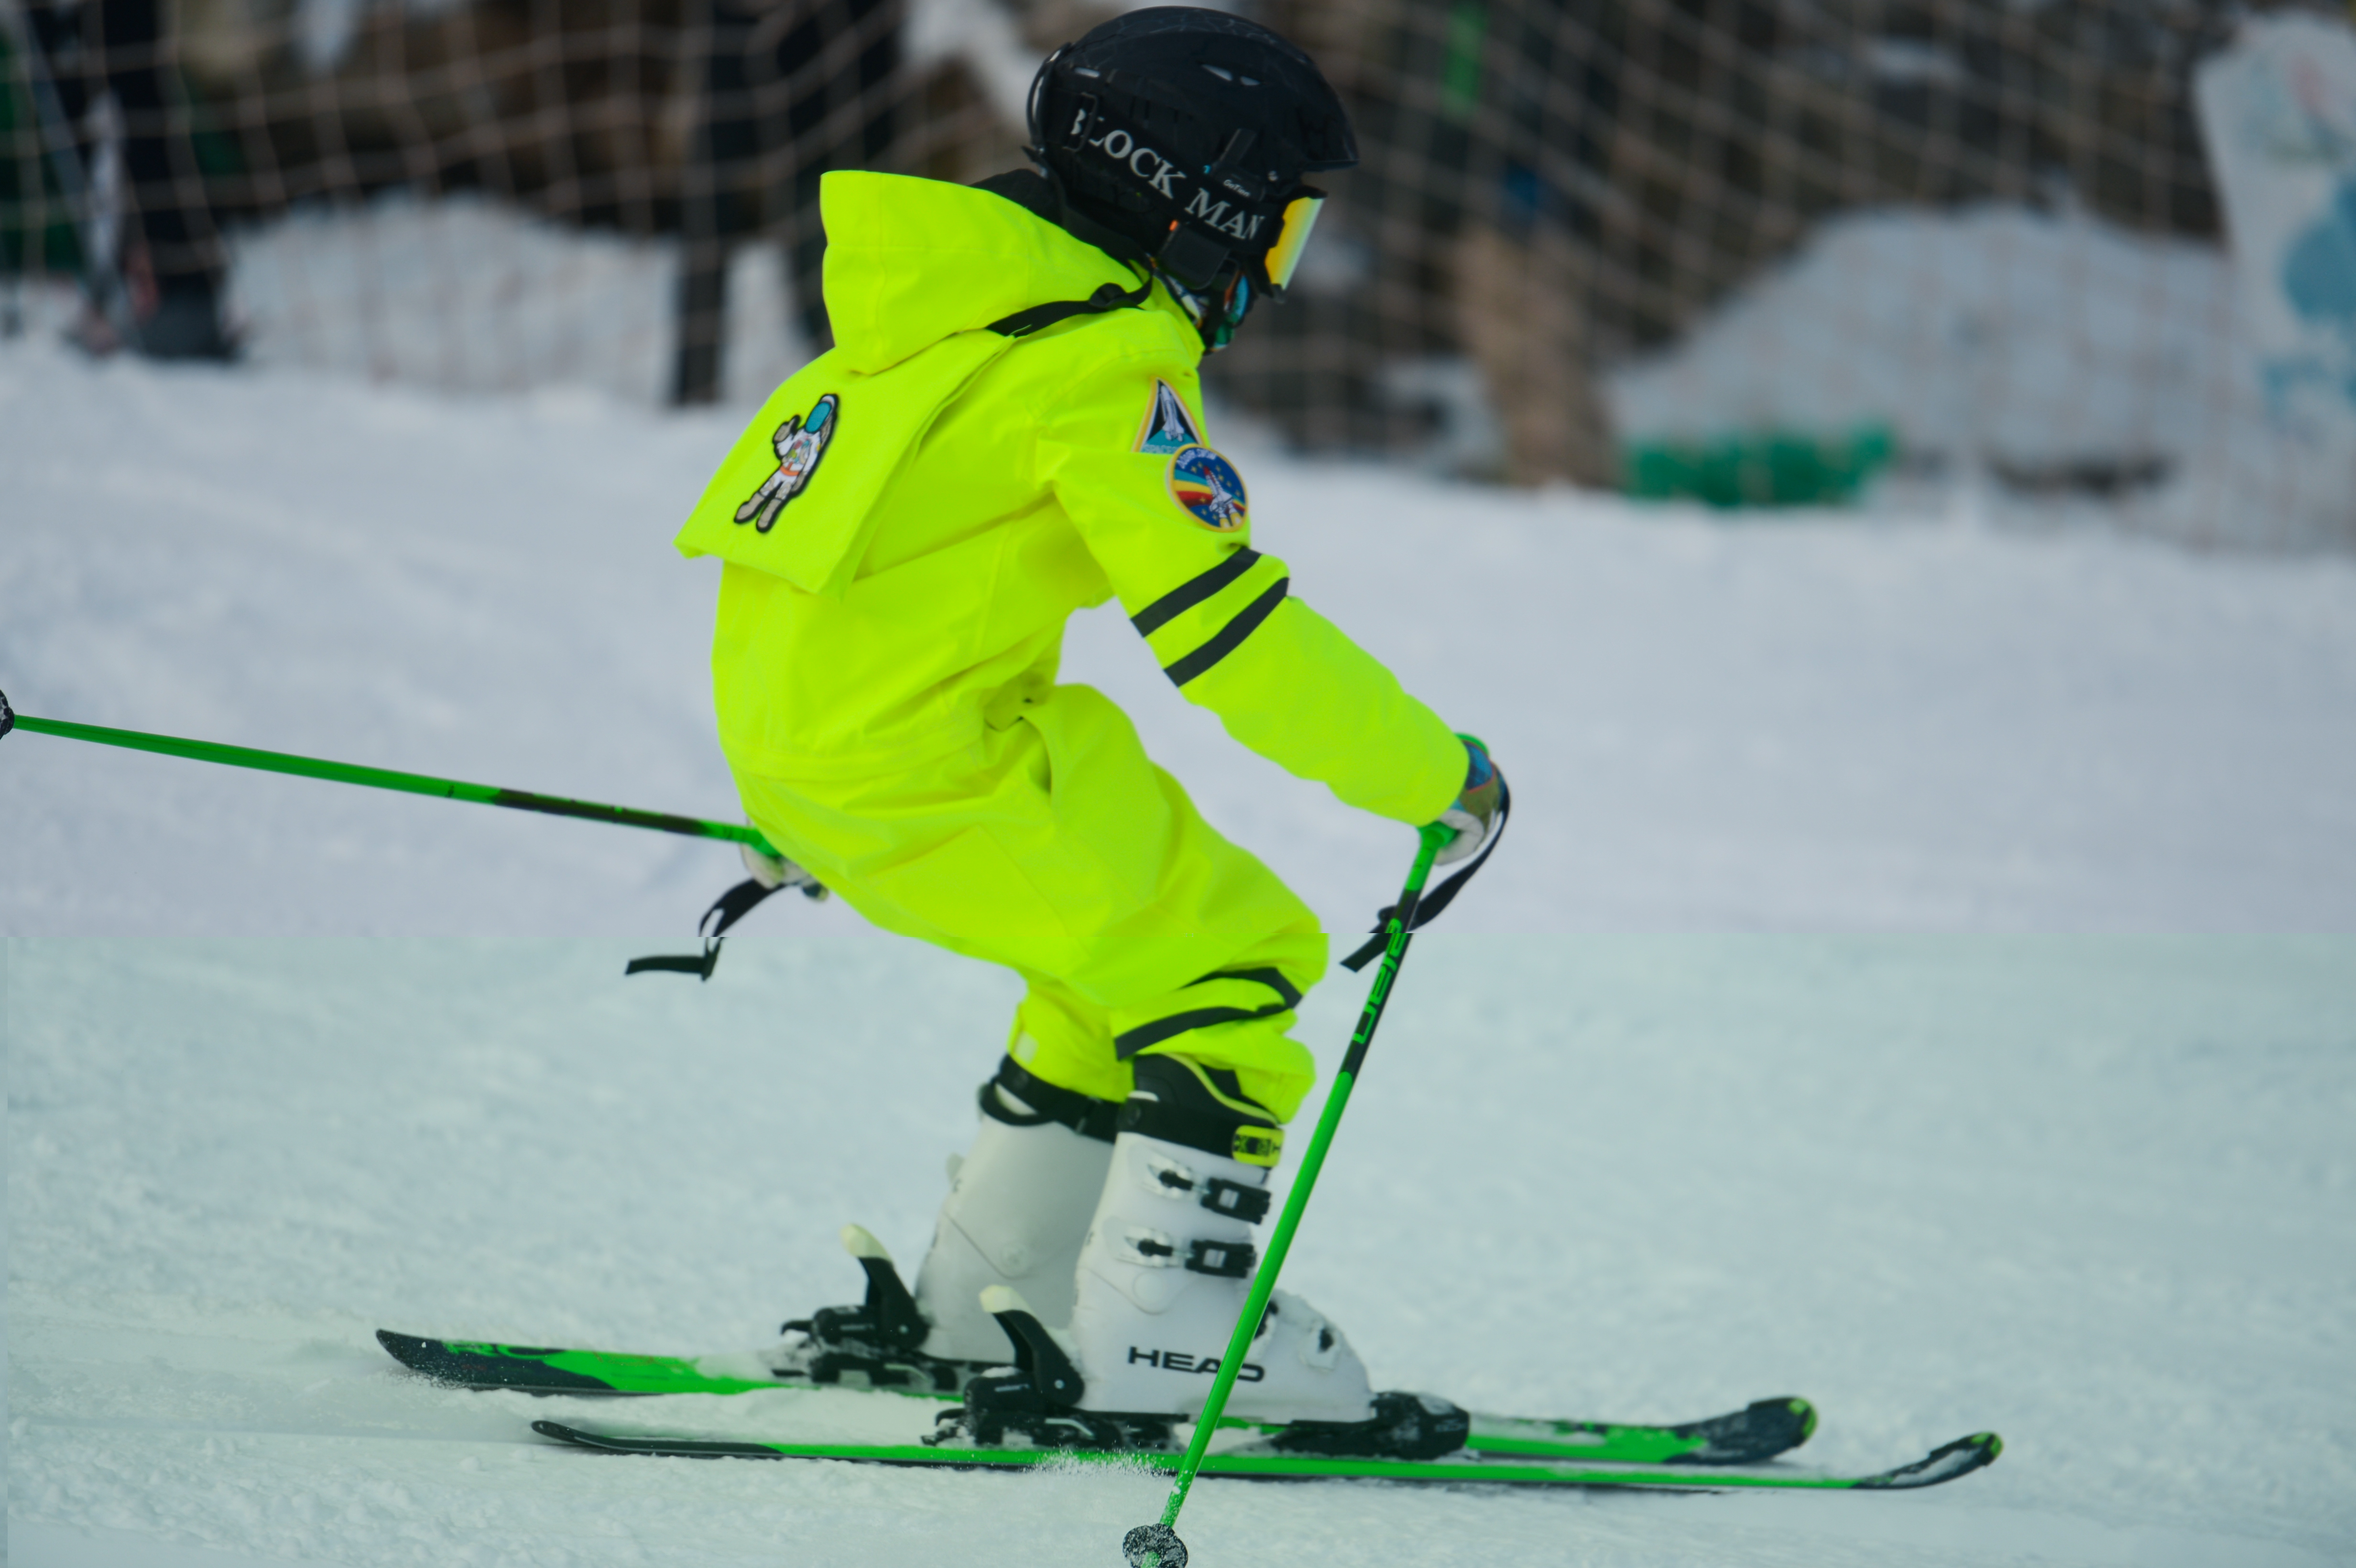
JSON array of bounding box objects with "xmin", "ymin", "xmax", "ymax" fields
[{"xmin": 940, "ymin": 1057, "xmax": 1468, "ymax": 1458}]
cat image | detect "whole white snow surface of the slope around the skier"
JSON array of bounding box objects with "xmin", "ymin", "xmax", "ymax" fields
[{"xmin": 0, "ymin": 344, "xmax": 2356, "ymax": 1568}]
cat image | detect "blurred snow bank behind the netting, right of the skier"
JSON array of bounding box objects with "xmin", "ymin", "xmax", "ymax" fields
[{"xmin": 1607, "ymin": 205, "xmax": 2356, "ymax": 546}]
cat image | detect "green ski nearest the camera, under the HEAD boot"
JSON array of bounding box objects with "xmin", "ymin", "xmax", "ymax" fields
[{"xmin": 533, "ymin": 1422, "xmax": 2005, "ymax": 1492}]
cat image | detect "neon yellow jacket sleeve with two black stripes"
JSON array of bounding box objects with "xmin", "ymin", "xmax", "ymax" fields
[{"xmin": 1041, "ymin": 379, "xmax": 1465, "ymax": 824}]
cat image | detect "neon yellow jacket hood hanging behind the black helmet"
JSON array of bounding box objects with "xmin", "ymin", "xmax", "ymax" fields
[{"xmin": 818, "ymin": 170, "xmax": 1138, "ymax": 374}]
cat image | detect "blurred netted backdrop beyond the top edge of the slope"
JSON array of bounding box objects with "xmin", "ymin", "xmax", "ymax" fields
[{"xmin": 0, "ymin": 0, "xmax": 2356, "ymax": 551}]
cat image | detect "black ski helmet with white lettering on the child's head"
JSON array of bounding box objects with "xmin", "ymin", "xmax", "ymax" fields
[{"xmin": 1030, "ymin": 5, "xmax": 1357, "ymax": 299}]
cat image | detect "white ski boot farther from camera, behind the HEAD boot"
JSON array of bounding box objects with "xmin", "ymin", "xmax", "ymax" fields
[{"xmin": 770, "ymin": 1057, "xmax": 1119, "ymax": 1392}]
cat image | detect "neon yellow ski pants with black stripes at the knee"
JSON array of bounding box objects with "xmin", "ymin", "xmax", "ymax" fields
[{"xmin": 737, "ymin": 685, "xmax": 1326, "ymax": 1121}]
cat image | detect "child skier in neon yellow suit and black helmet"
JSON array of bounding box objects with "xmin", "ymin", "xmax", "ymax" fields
[{"xmin": 678, "ymin": 7, "xmax": 1501, "ymax": 1453}]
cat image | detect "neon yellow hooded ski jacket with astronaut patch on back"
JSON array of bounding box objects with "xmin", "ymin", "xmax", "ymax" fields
[{"xmin": 676, "ymin": 172, "xmax": 1465, "ymax": 824}]
